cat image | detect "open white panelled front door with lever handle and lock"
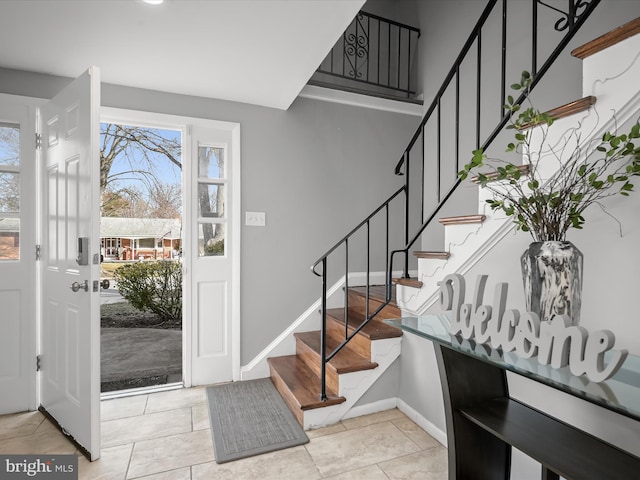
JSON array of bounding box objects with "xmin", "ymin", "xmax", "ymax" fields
[{"xmin": 40, "ymin": 67, "xmax": 100, "ymax": 460}]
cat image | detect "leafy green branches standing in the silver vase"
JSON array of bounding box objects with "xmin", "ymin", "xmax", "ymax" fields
[{"xmin": 458, "ymin": 71, "xmax": 640, "ymax": 241}]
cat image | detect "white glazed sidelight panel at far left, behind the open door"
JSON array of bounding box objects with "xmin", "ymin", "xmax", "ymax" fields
[{"xmin": 0, "ymin": 95, "xmax": 36, "ymax": 415}]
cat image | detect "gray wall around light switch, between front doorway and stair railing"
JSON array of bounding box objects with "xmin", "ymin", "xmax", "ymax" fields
[{"xmin": 0, "ymin": 69, "xmax": 419, "ymax": 365}]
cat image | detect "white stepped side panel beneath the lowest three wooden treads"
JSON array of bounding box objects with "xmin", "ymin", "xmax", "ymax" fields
[{"xmin": 302, "ymin": 337, "xmax": 402, "ymax": 430}]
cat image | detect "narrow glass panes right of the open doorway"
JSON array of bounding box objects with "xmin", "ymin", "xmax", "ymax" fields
[{"xmin": 197, "ymin": 145, "xmax": 227, "ymax": 257}]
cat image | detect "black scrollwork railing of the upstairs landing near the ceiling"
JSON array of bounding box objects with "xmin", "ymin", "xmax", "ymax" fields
[{"xmin": 317, "ymin": 12, "xmax": 420, "ymax": 98}]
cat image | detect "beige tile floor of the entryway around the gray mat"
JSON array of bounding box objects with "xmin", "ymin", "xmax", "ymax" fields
[{"xmin": 0, "ymin": 387, "xmax": 447, "ymax": 480}]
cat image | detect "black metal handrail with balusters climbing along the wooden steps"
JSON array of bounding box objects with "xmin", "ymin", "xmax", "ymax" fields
[{"xmin": 312, "ymin": 0, "xmax": 601, "ymax": 400}]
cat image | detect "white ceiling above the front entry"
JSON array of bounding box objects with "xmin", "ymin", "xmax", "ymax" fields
[{"xmin": 0, "ymin": 0, "xmax": 365, "ymax": 109}]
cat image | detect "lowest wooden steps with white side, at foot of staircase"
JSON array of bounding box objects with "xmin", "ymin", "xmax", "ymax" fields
[{"xmin": 267, "ymin": 287, "xmax": 402, "ymax": 429}]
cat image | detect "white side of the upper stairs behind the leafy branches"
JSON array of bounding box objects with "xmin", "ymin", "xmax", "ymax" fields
[{"xmin": 396, "ymin": 30, "xmax": 640, "ymax": 315}]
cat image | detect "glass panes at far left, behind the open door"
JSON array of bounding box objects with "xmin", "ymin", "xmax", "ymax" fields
[{"xmin": 0, "ymin": 123, "xmax": 20, "ymax": 261}]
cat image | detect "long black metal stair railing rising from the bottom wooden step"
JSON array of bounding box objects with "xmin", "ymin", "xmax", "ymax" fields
[{"xmin": 312, "ymin": 0, "xmax": 600, "ymax": 400}]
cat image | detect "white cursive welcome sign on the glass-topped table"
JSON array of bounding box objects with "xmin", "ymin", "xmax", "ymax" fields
[{"xmin": 440, "ymin": 274, "xmax": 628, "ymax": 382}]
